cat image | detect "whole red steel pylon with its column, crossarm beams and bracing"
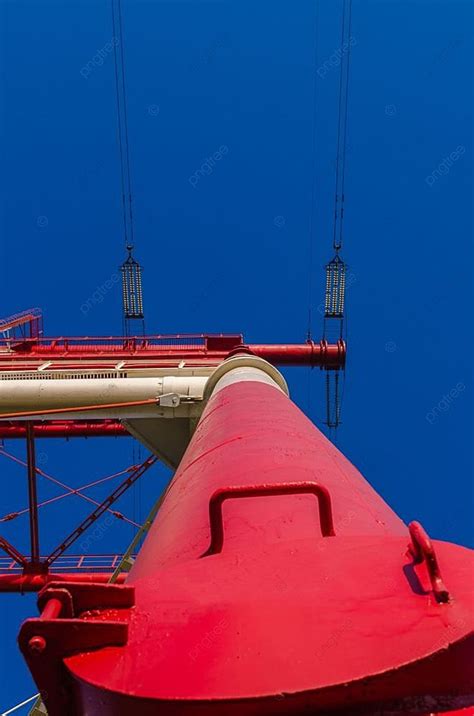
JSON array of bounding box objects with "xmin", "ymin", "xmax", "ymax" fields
[{"xmin": 0, "ymin": 326, "xmax": 474, "ymax": 716}]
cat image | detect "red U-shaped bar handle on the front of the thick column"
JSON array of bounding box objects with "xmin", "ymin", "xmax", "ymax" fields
[{"xmin": 202, "ymin": 481, "xmax": 336, "ymax": 557}]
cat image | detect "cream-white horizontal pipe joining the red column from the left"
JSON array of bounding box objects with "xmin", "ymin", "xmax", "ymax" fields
[{"xmin": 0, "ymin": 376, "xmax": 208, "ymax": 420}]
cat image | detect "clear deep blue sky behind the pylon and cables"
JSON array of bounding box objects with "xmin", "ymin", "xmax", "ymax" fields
[{"xmin": 0, "ymin": 0, "xmax": 474, "ymax": 709}]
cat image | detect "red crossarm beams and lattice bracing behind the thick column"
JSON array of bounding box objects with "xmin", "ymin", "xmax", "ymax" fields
[{"xmin": 0, "ymin": 309, "xmax": 345, "ymax": 591}]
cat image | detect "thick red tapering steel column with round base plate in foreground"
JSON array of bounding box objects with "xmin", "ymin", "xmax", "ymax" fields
[{"xmin": 22, "ymin": 381, "xmax": 474, "ymax": 716}]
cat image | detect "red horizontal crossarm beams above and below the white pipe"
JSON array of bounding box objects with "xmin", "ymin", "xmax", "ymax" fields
[{"xmin": 0, "ymin": 334, "xmax": 346, "ymax": 440}]
